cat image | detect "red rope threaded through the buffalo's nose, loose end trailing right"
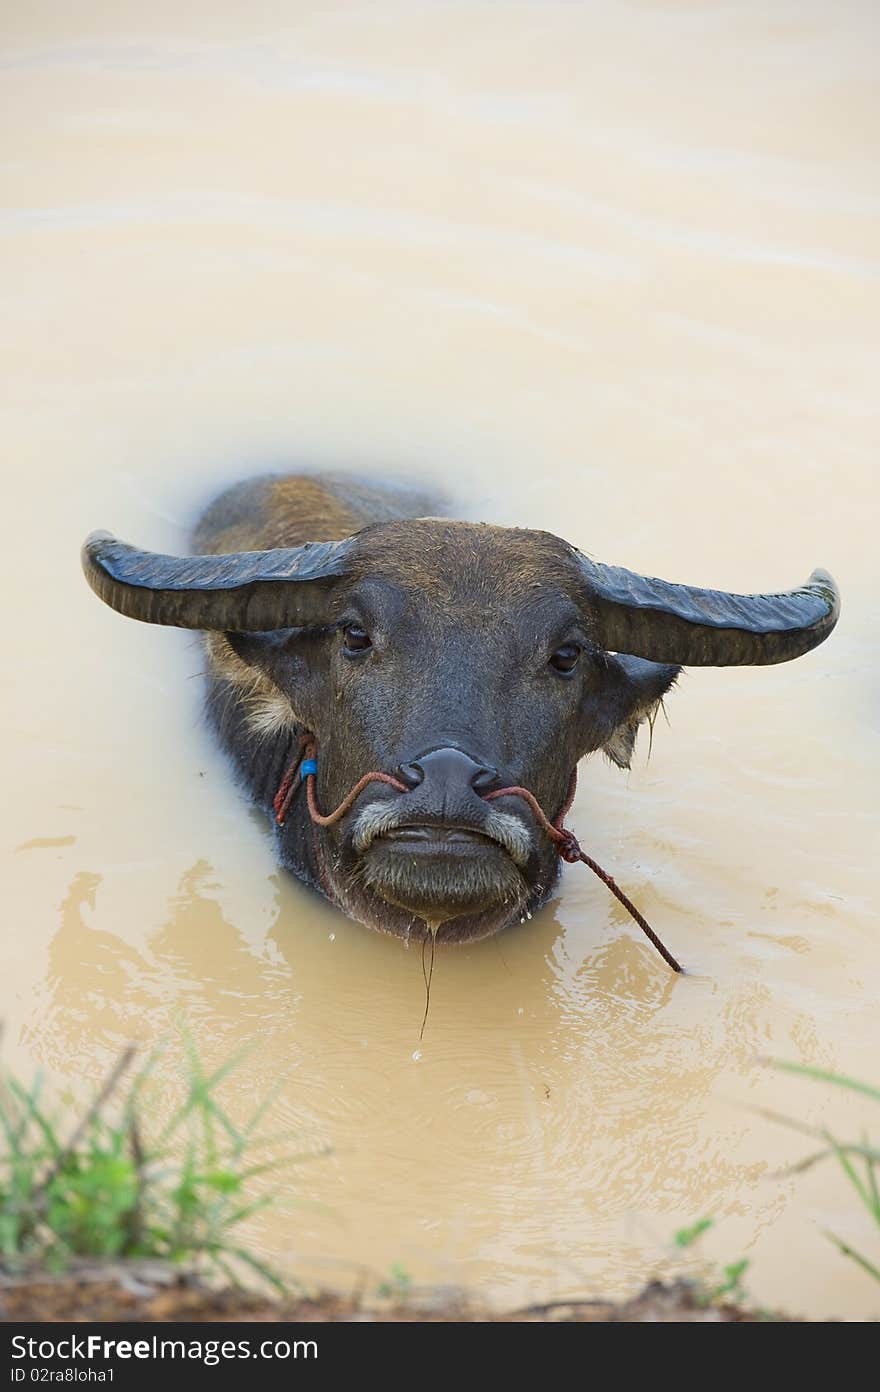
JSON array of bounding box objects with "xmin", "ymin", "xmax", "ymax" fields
[{"xmin": 273, "ymin": 735, "xmax": 684, "ymax": 972}]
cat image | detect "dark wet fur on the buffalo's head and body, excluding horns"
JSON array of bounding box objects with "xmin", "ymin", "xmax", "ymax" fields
[{"xmin": 194, "ymin": 476, "xmax": 678, "ymax": 941}]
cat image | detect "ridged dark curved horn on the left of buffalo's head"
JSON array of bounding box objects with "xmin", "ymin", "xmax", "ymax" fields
[{"xmin": 82, "ymin": 532, "xmax": 352, "ymax": 633}]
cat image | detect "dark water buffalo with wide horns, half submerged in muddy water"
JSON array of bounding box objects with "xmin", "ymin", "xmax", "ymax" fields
[{"xmin": 84, "ymin": 476, "xmax": 838, "ymax": 942}]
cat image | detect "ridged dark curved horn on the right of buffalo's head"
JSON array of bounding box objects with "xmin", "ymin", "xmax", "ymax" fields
[{"xmin": 578, "ymin": 553, "xmax": 840, "ymax": 667}]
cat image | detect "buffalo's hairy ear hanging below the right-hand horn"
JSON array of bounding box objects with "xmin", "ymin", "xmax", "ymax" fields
[{"xmin": 588, "ymin": 653, "xmax": 681, "ymax": 768}]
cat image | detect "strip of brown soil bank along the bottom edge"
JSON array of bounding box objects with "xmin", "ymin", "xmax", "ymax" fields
[{"xmin": 0, "ymin": 1263, "xmax": 785, "ymax": 1324}]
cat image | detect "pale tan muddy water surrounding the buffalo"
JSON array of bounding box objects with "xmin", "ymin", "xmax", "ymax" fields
[{"xmin": 0, "ymin": 0, "xmax": 880, "ymax": 1315}]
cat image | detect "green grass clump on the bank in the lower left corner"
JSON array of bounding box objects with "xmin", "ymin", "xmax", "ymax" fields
[{"xmin": 0, "ymin": 1041, "xmax": 294, "ymax": 1290}]
